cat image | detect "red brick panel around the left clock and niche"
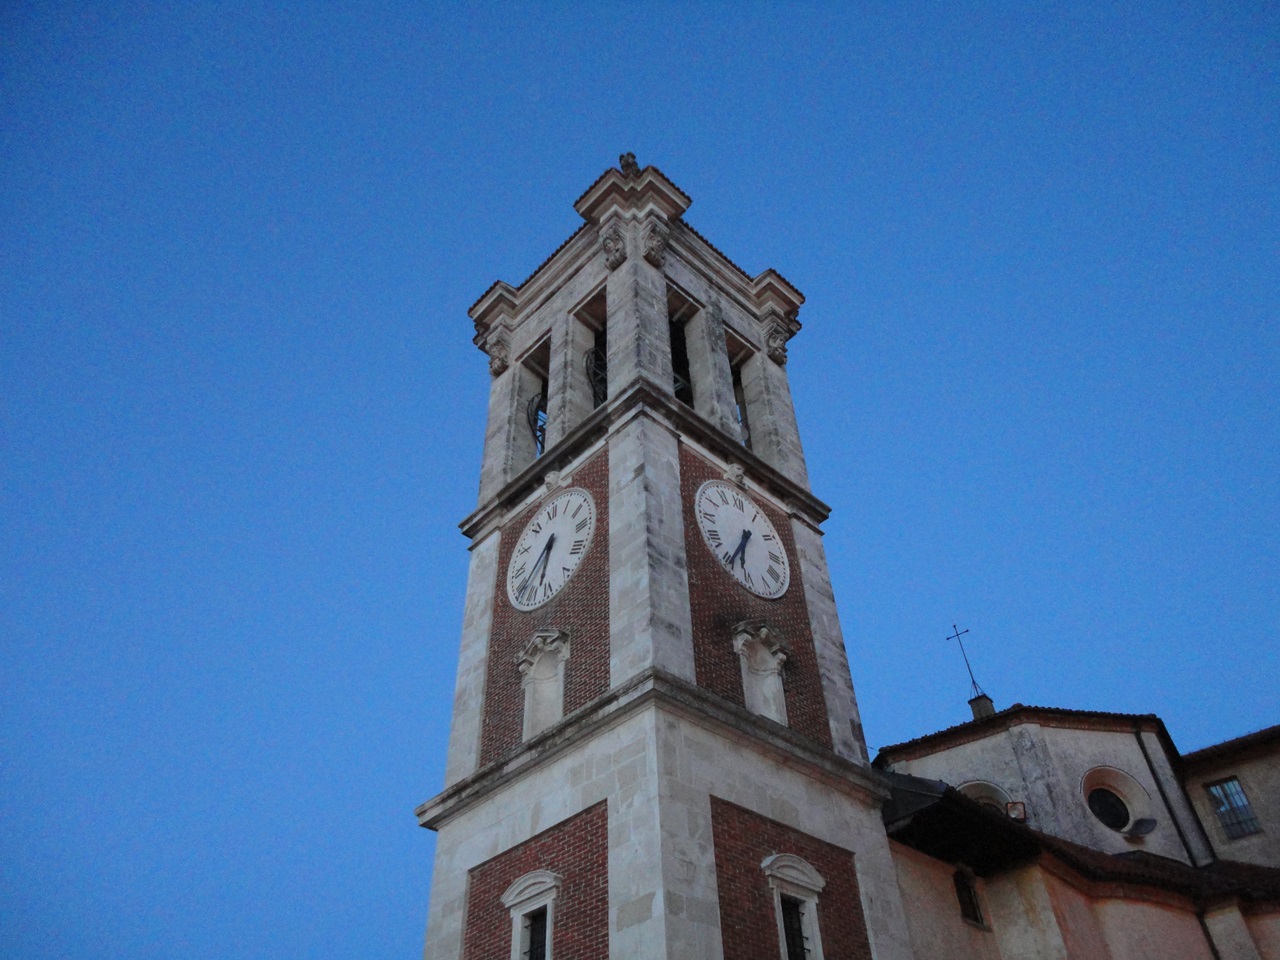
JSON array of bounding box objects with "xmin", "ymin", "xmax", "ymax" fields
[{"xmin": 480, "ymin": 451, "xmax": 609, "ymax": 765}]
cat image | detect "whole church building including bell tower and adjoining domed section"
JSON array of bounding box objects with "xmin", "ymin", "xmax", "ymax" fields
[{"xmin": 416, "ymin": 154, "xmax": 1280, "ymax": 960}]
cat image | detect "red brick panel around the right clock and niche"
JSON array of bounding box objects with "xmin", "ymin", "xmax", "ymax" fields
[{"xmin": 680, "ymin": 445, "xmax": 831, "ymax": 748}]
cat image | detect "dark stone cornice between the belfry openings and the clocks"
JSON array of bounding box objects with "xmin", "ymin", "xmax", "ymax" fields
[{"xmin": 458, "ymin": 379, "xmax": 831, "ymax": 540}]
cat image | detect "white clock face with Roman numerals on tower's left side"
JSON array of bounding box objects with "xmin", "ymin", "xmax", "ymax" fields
[{"xmin": 507, "ymin": 488, "xmax": 595, "ymax": 611}]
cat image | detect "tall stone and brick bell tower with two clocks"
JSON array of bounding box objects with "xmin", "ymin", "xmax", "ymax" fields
[{"xmin": 417, "ymin": 155, "xmax": 909, "ymax": 960}]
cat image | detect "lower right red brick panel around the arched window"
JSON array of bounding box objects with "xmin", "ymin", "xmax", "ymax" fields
[{"xmin": 712, "ymin": 796, "xmax": 872, "ymax": 960}]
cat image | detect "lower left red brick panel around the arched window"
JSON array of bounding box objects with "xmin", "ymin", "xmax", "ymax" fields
[{"xmin": 462, "ymin": 801, "xmax": 609, "ymax": 960}]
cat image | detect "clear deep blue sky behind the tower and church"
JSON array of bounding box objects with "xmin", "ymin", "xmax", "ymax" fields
[{"xmin": 0, "ymin": 0, "xmax": 1280, "ymax": 960}]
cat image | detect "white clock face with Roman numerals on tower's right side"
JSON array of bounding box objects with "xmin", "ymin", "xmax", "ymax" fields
[{"xmin": 694, "ymin": 480, "xmax": 791, "ymax": 600}]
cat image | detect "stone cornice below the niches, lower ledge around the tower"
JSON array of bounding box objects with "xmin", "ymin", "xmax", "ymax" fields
[{"xmin": 413, "ymin": 668, "xmax": 890, "ymax": 829}]
